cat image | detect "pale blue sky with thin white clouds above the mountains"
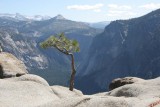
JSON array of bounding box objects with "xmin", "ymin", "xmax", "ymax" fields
[{"xmin": 0, "ymin": 0, "xmax": 160, "ymax": 22}]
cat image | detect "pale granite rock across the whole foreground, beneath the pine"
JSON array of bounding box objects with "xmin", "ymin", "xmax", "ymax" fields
[{"xmin": 0, "ymin": 53, "xmax": 160, "ymax": 107}]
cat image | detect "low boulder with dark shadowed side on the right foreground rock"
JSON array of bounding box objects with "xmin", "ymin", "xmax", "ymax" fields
[{"xmin": 109, "ymin": 77, "xmax": 143, "ymax": 90}]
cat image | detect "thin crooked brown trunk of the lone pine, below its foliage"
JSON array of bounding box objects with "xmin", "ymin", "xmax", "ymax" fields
[{"xmin": 69, "ymin": 54, "xmax": 76, "ymax": 91}]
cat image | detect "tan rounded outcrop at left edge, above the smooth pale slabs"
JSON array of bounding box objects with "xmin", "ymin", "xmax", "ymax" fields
[{"xmin": 0, "ymin": 52, "xmax": 28, "ymax": 78}]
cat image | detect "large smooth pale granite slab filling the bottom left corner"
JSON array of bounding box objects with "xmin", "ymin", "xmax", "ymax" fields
[{"xmin": 0, "ymin": 77, "xmax": 59, "ymax": 107}]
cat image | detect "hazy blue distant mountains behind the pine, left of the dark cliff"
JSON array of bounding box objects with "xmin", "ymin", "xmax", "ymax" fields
[{"xmin": 0, "ymin": 14, "xmax": 101, "ymax": 85}]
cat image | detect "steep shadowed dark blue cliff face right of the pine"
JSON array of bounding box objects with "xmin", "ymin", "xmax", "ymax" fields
[{"xmin": 77, "ymin": 10, "xmax": 160, "ymax": 93}]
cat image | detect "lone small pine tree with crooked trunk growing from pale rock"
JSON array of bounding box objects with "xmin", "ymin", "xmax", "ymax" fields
[{"xmin": 40, "ymin": 33, "xmax": 80, "ymax": 91}]
